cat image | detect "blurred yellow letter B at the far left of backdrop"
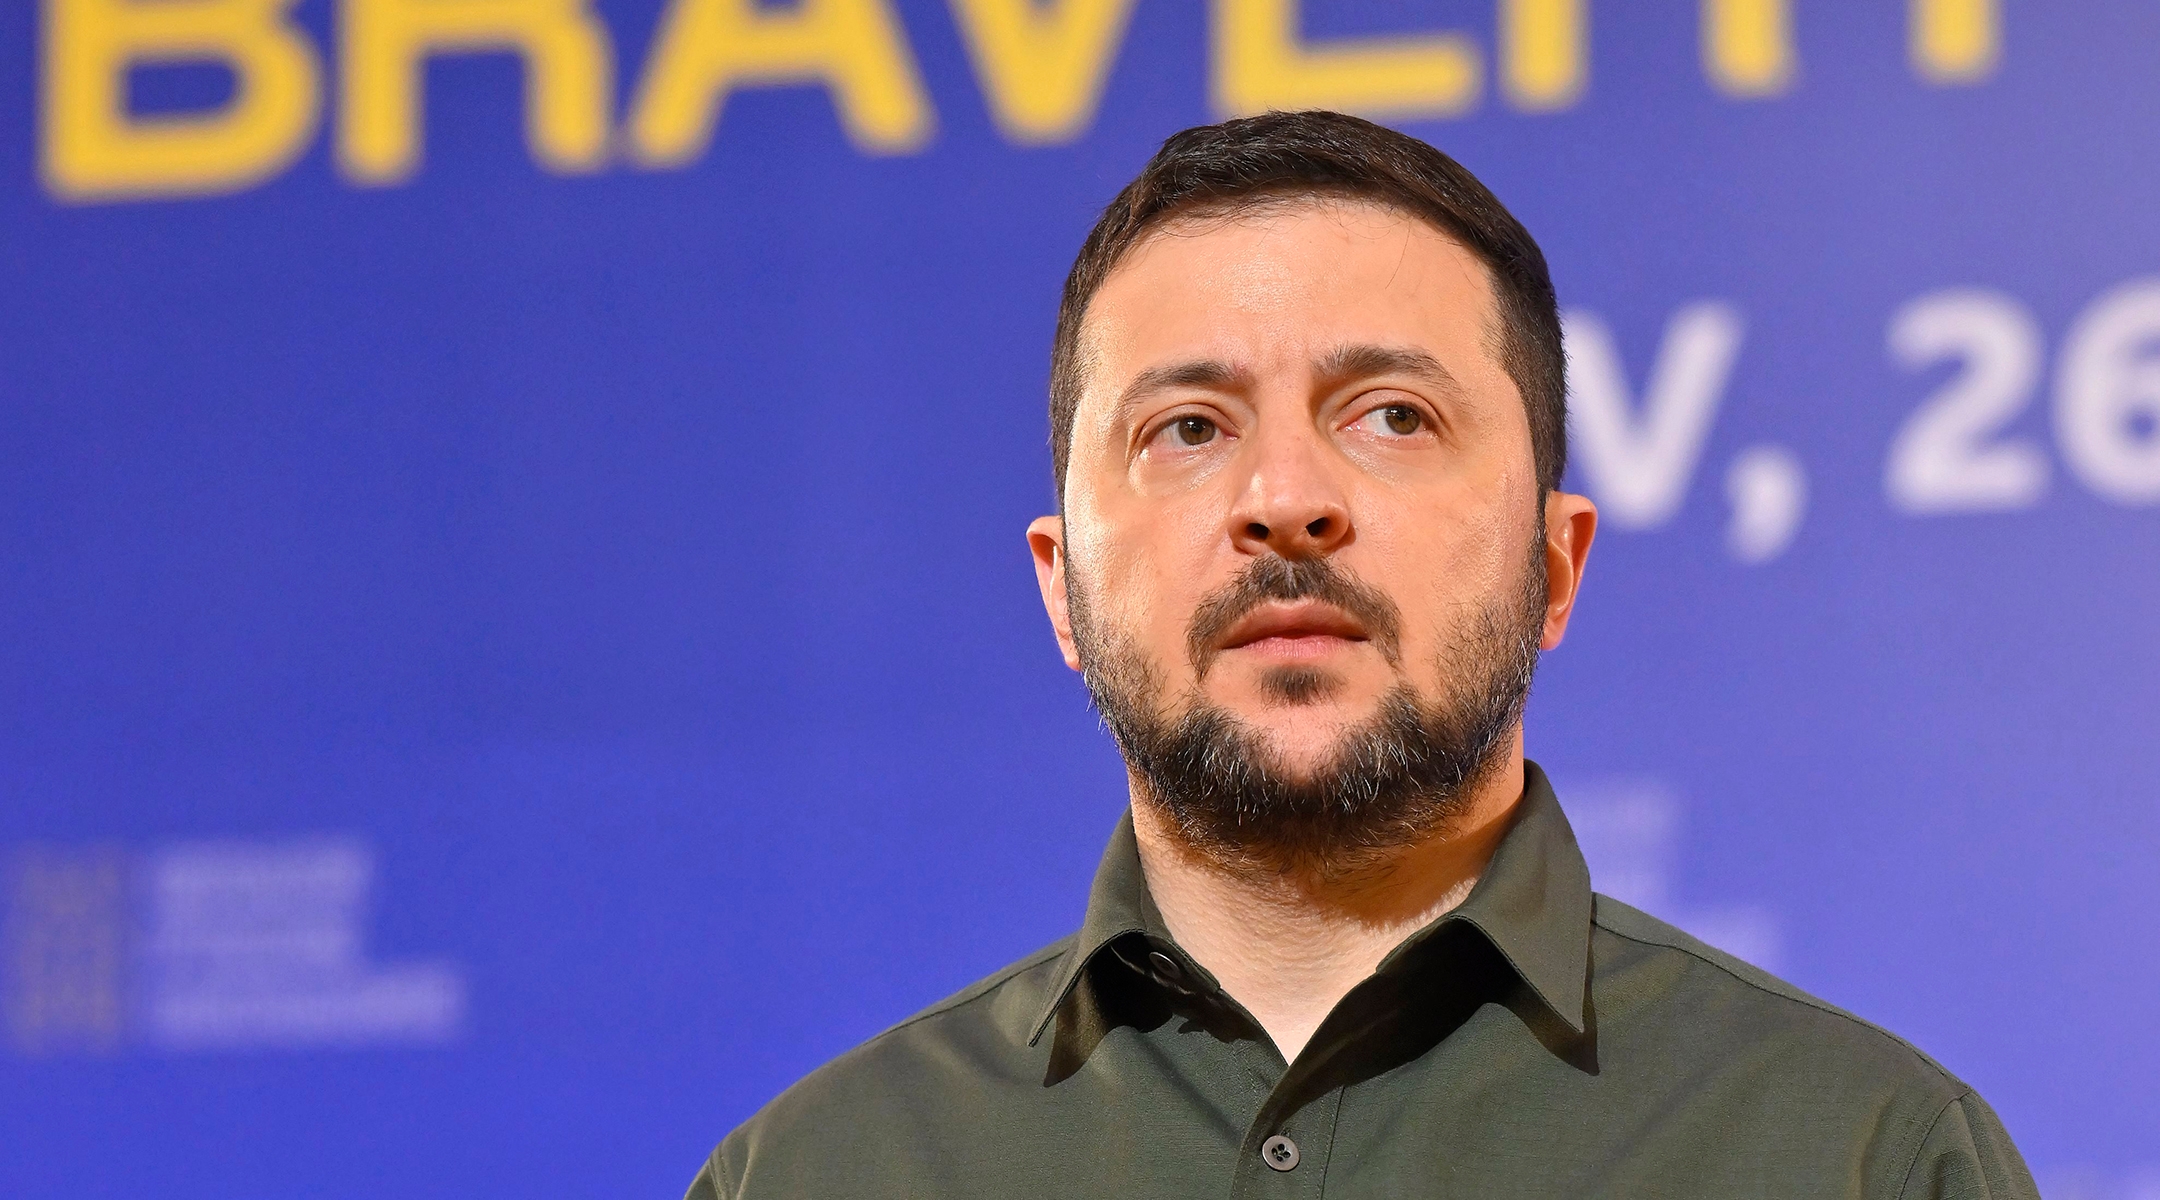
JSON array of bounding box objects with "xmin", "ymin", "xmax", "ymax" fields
[{"xmin": 39, "ymin": 0, "xmax": 322, "ymax": 201}]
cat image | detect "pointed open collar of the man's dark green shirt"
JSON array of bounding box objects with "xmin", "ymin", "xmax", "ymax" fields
[{"xmin": 1028, "ymin": 762, "xmax": 1590, "ymax": 1045}]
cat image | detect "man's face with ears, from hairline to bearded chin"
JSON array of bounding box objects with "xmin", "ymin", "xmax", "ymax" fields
[{"xmin": 1030, "ymin": 201, "xmax": 1588, "ymax": 863}]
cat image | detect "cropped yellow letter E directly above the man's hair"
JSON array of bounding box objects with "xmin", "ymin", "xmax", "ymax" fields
[{"xmin": 1214, "ymin": 0, "xmax": 1482, "ymax": 117}]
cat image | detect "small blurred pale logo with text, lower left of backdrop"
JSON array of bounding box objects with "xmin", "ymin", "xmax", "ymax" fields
[{"xmin": 0, "ymin": 837, "xmax": 467, "ymax": 1053}]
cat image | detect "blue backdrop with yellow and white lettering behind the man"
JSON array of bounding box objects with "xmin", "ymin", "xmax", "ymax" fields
[{"xmin": 0, "ymin": 0, "xmax": 2160, "ymax": 1200}]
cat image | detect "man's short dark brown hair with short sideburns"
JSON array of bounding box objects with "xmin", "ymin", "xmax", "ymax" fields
[{"xmin": 1050, "ymin": 112, "xmax": 1568, "ymax": 500}]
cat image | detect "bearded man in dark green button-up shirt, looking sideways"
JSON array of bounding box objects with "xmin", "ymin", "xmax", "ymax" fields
[{"xmin": 691, "ymin": 112, "xmax": 2035, "ymax": 1200}]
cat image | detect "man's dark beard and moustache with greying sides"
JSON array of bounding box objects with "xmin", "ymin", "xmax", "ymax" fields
[{"xmin": 1065, "ymin": 528, "xmax": 1547, "ymax": 878}]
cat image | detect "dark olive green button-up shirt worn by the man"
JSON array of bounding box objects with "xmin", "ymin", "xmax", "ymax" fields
[{"xmin": 689, "ymin": 766, "xmax": 2037, "ymax": 1200}]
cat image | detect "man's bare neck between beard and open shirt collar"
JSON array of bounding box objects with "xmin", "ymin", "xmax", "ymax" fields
[{"xmin": 1132, "ymin": 732, "xmax": 1523, "ymax": 1062}]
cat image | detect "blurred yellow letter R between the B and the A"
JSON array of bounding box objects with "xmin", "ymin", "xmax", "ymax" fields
[{"xmin": 337, "ymin": 0, "xmax": 616, "ymax": 183}]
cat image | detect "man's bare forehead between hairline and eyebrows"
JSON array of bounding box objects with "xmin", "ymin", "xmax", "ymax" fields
[{"xmin": 1078, "ymin": 199, "xmax": 1499, "ymax": 390}]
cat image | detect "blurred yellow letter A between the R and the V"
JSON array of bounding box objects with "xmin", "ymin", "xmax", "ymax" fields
[{"xmin": 631, "ymin": 0, "xmax": 935, "ymax": 166}]
